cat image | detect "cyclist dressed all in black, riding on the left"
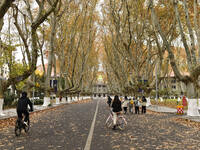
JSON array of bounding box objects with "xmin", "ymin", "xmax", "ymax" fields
[{"xmin": 17, "ymin": 92, "xmax": 33, "ymax": 125}]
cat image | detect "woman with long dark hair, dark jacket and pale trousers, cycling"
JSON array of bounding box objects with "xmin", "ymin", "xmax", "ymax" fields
[{"xmin": 111, "ymin": 95, "xmax": 122, "ymax": 130}]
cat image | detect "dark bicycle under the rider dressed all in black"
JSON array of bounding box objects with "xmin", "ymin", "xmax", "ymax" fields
[{"xmin": 15, "ymin": 112, "xmax": 30, "ymax": 136}]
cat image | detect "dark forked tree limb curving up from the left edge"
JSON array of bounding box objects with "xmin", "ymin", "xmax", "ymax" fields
[{"xmin": 0, "ymin": 0, "xmax": 58, "ymax": 97}]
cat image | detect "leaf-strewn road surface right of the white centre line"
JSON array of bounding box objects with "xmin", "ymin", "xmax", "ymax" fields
[{"xmin": 92, "ymin": 100, "xmax": 200, "ymax": 150}]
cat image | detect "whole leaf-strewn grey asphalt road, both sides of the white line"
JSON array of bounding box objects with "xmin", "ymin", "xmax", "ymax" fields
[{"xmin": 0, "ymin": 100, "xmax": 200, "ymax": 150}]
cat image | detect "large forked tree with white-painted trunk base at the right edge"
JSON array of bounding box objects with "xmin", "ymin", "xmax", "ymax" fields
[{"xmin": 149, "ymin": 0, "xmax": 200, "ymax": 116}]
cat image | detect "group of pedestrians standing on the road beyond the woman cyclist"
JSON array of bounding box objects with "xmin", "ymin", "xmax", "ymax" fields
[{"xmin": 107, "ymin": 95, "xmax": 147, "ymax": 114}]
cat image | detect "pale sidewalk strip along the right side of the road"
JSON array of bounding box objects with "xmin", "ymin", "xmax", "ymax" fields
[{"xmin": 147, "ymin": 105, "xmax": 200, "ymax": 122}]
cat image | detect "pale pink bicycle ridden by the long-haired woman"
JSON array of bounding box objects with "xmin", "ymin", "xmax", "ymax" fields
[{"xmin": 105, "ymin": 110, "xmax": 127, "ymax": 130}]
